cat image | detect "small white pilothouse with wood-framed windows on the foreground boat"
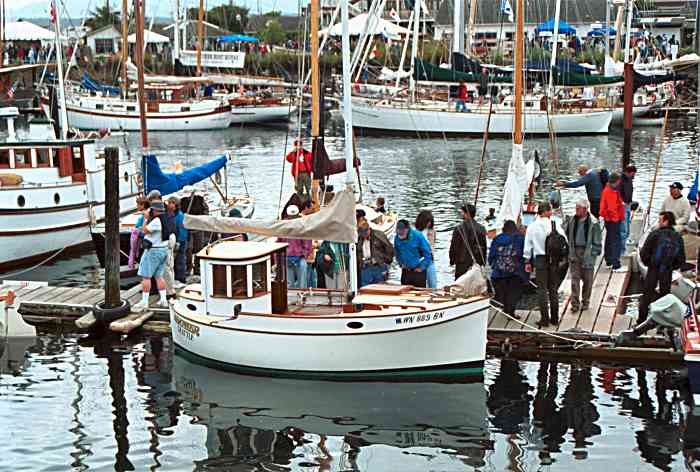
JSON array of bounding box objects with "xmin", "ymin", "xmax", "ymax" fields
[{"xmin": 198, "ymin": 241, "xmax": 288, "ymax": 316}]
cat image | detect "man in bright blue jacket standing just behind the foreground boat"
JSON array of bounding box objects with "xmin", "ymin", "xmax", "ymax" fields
[{"xmin": 394, "ymin": 220, "xmax": 433, "ymax": 287}]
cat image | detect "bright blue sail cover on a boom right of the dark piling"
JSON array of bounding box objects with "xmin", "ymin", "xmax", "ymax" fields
[{"xmin": 141, "ymin": 154, "xmax": 227, "ymax": 195}]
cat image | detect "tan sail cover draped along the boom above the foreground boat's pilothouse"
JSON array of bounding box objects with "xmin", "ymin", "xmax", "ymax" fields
[{"xmin": 185, "ymin": 190, "xmax": 357, "ymax": 243}]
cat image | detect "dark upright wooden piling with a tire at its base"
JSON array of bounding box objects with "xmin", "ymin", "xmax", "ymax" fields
[{"xmin": 104, "ymin": 147, "xmax": 121, "ymax": 308}]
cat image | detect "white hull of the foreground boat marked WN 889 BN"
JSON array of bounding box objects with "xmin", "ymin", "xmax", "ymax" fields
[{"xmin": 170, "ymin": 297, "xmax": 489, "ymax": 377}]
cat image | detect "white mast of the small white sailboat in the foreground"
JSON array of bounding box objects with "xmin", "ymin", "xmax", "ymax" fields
[{"xmin": 340, "ymin": 0, "xmax": 358, "ymax": 293}]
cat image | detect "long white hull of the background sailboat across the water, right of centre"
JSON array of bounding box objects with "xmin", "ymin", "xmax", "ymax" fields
[{"xmin": 352, "ymin": 100, "xmax": 613, "ymax": 136}]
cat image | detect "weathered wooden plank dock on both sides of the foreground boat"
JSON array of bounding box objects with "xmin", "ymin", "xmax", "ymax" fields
[{"xmin": 2, "ymin": 257, "xmax": 682, "ymax": 365}]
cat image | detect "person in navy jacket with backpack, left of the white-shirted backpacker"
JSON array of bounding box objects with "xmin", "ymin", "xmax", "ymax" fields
[{"xmin": 489, "ymin": 220, "xmax": 528, "ymax": 318}]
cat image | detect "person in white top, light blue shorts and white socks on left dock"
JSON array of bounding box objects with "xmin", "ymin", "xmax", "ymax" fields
[{"xmin": 131, "ymin": 200, "xmax": 170, "ymax": 312}]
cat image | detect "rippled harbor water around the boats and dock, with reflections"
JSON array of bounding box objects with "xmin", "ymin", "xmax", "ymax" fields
[{"xmin": 0, "ymin": 120, "xmax": 700, "ymax": 471}]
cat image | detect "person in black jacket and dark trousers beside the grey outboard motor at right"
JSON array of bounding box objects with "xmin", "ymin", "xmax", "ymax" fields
[{"xmin": 637, "ymin": 211, "xmax": 685, "ymax": 324}]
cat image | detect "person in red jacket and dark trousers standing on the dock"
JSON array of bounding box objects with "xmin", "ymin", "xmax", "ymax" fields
[{"xmin": 600, "ymin": 173, "xmax": 626, "ymax": 272}]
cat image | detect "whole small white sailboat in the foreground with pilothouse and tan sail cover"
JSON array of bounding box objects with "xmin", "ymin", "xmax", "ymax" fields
[{"xmin": 170, "ymin": 0, "xmax": 489, "ymax": 379}]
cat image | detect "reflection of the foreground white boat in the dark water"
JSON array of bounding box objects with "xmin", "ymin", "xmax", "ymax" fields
[{"xmin": 173, "ymin": 356, "xmax": 493, "ymax": 470}]
